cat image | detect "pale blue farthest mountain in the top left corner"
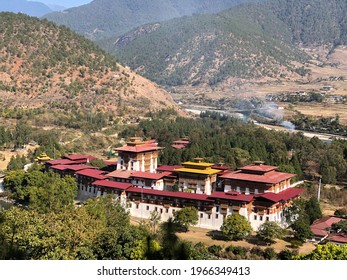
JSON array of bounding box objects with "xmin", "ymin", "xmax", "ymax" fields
[{"xmin": 0, "ymin": 0, "xmax": 53, "ymax": 17}]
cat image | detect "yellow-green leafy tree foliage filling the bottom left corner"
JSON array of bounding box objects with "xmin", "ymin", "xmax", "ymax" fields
[{"xmin": 0, "ymin": 207, "xmax": 102, "ymax": 260}]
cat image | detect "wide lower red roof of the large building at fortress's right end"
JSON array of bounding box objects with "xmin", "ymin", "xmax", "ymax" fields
[{"xmin": 220, "ymin": 170, "xmax": 296, "ymax": 184}]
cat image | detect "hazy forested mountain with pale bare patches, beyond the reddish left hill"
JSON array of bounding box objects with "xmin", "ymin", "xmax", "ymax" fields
[{"xmin": 105, "ymin": 5, "xmax": 307, "ymax": 86}]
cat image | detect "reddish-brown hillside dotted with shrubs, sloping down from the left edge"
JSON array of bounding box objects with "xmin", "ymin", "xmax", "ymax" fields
[{"xmin": 0, "ymin": 13, "xmax": 178, "ymax": 115}]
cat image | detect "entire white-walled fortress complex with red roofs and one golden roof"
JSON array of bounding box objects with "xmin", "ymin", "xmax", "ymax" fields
[{"xmin": 40, "ymin": 137, "xmax": 312, "ymax": 230}]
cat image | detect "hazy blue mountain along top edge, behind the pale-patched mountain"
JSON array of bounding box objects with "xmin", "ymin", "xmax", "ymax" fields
[{"xmin": 45, "ymin": 0, "xmax": 264, "ymax": 40}]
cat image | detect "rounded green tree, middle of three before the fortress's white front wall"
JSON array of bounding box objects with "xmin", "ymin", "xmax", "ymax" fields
[{"xmin": 220, "ymin": 213, "xmax": 252, "ymax": 240}]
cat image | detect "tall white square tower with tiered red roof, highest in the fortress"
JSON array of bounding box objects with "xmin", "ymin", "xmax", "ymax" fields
[{"xmin": 115, "ymin": 137, "xmax": 163, "ymax": 173}]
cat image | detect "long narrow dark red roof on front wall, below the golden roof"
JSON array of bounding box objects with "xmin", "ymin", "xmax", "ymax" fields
[{"xmin": 127, "ymin": 187, "xmax": 213, "ymax": 203}]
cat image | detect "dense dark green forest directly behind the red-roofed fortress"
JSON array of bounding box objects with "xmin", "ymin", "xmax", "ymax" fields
[{"xmin": 120, "ymin": 112, "xmax": 347, "ymax": 183}]
